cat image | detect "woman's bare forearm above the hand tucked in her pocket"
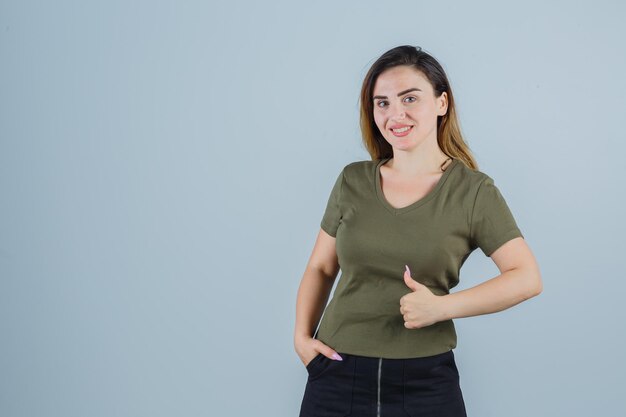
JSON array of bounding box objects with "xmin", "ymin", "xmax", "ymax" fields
[{"xmin": 294, "ymin": 267, "xmax": 336, "ymax": 339}]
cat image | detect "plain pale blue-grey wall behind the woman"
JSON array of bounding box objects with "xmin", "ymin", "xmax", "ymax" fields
[{"xmin": 0, "ymin": 1, "xmax": 626, "ymax": 417}]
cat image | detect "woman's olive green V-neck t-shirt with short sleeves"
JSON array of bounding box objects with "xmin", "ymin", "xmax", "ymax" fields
[{"xmin": 315, "ymin": 158, "xmax": 523, "ymax": 359}]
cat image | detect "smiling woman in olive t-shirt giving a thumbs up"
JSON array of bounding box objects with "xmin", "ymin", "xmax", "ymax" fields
[{"xmin": 294, "ymin": 45, "xmax": 542, "ymax": 417}]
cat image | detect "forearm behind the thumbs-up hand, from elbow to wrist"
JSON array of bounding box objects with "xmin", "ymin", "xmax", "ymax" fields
[{"xmin": 441, "ymin": 268, "xmax": 541, "ymax": 320}]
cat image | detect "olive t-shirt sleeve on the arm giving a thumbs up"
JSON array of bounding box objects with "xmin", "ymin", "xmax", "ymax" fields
[{"xmin": 470, "ymin": 177, "xmax": 524, "ymax": 256}]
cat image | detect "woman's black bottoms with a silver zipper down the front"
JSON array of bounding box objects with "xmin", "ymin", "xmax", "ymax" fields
[{"xmin": 300, "ymin": 350, "xmax": 467, "ymax": 417}]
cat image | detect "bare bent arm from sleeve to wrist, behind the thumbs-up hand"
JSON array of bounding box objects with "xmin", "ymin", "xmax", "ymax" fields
[{"xmin": 441, "ymin": 237, "xmax": 543, "ymax": 320}]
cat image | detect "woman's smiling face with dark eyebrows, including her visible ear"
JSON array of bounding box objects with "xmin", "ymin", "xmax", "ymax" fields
[{"xmin": 372, "ymin": 65, "xmax": 448, "ymax": 150}]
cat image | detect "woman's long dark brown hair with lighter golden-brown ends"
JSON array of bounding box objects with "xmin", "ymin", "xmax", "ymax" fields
[{"xmin": 360, "ymin": 45, "xmax": 478, "ymax": 170}]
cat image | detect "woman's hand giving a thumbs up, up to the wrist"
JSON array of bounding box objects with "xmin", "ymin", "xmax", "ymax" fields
[{"xmin": 400, "ymin": 265, "xmax": 444, "ymax": 329}]
